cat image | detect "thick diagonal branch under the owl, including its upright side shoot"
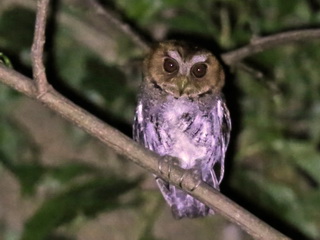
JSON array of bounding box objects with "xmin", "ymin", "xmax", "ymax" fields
[{"xmin": 0, "ymin": 0, "xmax": 288, "ymax": 240}]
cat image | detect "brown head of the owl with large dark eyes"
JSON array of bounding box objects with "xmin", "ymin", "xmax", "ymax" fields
[{"xmin": 144, "ymin": 41, "xmax": 224, "ymax": 97}]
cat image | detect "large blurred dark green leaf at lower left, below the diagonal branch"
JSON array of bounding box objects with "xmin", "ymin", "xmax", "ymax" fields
[{"xmin": 22, "ymin": 177, "xmax": 140, "ymax": 240}]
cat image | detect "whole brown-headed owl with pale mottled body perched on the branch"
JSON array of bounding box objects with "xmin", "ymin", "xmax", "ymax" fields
[{"xmin": 133, "ymin": 40, "xmax": 231, "ymax": 219}]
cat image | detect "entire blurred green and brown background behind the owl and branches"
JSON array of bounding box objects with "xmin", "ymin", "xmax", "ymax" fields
[{"xmin": 0, "ymin": 0, "xmax": 320, "ymax": 240}]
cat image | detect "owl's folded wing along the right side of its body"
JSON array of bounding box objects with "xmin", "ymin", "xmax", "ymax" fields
[{"xmin": 211, "ymin": 98, "xmax": 231, "ymax": 186}]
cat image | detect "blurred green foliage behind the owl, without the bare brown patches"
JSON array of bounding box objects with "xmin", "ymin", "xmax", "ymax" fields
[{"xmin": 0, "ymin": 0, "xmax": 320, "ymax": 239}]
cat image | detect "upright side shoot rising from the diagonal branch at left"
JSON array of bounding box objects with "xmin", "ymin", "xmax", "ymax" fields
[{"xmin": 32, "ymin": 0, "xmax": 49, "ymax": 97}]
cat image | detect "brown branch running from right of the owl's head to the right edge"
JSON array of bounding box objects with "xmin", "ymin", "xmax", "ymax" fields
[{"xmin": 221, "ymin": 29, "xmax": 320, "ymax": 65}]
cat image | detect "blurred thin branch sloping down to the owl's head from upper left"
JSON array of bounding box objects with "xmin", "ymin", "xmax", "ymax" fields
[{"xmin": 89, "ymin": 0, "xmax": 150, "ymax": 52}]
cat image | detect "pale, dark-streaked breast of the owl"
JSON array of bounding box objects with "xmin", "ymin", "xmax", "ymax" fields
[{"xmin": 152, "ymin": 99, "xmax": 214, "ymax": 169}]
